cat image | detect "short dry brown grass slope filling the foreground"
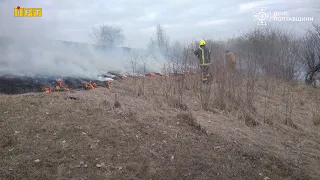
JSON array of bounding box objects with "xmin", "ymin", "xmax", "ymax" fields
[{"xmin": 0, "ymin": 78, "xmax": 320, "ymax": 180}]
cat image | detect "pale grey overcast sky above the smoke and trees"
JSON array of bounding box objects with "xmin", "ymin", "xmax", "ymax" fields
[{"xmin": 0, "ymin": 0, "xmax": 320, "ymax": 48}]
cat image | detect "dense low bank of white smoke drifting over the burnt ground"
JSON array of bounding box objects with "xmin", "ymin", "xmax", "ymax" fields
[{"xmin": 0, "ymin": 39, "xmax": 136, "ymax": 78}]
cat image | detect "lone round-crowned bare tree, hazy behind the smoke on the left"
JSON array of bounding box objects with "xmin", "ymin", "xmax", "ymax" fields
[{"xmin": 92, "ymin": 25, "xmax": 124, "ymax": 48}]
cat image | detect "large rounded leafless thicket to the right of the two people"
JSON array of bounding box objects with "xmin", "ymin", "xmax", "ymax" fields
[{"xmin": 238, "ymin": 27, "xmax": 300, "ymax": 80}]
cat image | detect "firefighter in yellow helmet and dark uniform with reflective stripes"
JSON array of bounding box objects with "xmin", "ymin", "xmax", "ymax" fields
[{"xmin": 194, "ymin": 40, "xmax": 211, "ymax": 82}]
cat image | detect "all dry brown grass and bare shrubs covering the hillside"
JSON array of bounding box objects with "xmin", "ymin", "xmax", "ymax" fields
[{"xmin": 0, "ymin": 23, "xmax": 320, "ymax": 179}]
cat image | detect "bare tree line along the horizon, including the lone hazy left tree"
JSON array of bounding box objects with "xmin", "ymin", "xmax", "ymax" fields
[{"xmin": 93, "ymin": 23, "xmax": 320, "ymax": 85}]
